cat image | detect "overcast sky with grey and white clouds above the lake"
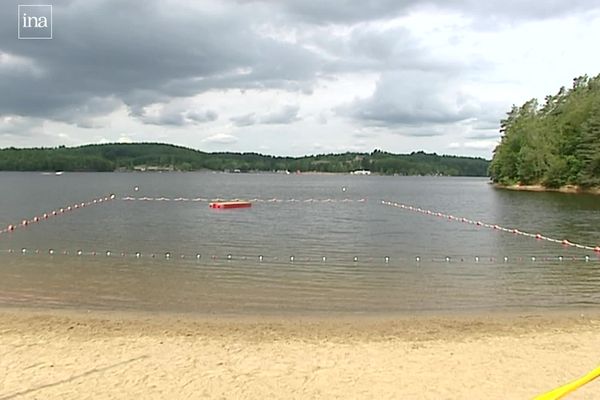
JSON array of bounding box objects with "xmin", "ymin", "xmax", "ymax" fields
[{"xmin": 0, "ymin": 0, "xmax": 600, "ymax": 158}]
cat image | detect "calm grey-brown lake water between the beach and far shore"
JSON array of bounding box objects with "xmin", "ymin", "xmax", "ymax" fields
[{"xmin": 0, "ymin": 173, "xmax": 600, "ymax": 315}]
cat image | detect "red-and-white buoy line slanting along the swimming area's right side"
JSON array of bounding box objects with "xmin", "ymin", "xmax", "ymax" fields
[{"xmin": 381, "ymin": 200, "xmax": 600, "ymax": 253}]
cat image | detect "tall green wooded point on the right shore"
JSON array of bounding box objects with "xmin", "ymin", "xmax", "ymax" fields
[{"xmin": 490, "ymin": 75, "xmax": 600, "ymax": 188}]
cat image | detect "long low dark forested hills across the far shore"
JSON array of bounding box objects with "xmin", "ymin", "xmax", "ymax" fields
[{"xmin": 0, "ymin": 143, "xmax": 489, "ymax": 176}]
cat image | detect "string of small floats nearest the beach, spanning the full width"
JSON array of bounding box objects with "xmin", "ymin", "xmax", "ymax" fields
[{"xmin": 0, "ymin": 247, "xmax": 600, "ymax": 265}]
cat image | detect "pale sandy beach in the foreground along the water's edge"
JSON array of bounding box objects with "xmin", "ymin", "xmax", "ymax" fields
[{"xmin": 0, "ymin": 309, "xmax": 600, "ymax": 400}]
